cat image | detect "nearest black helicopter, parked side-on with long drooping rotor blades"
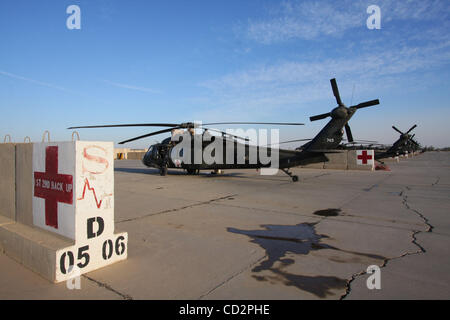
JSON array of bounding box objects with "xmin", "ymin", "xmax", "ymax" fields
[{"xmin": 68, "ymin": 79, "xmax": 380, "ymax": 182}]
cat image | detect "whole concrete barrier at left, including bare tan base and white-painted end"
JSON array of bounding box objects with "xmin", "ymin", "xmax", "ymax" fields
[{"xmin": 0, "ymin": 141, "xmax": 128, "ymax": 282}]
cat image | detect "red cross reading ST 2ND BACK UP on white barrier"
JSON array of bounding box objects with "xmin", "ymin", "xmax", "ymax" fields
[{"xmin": 34, "ymin": 146, "xmax": 73, "ymax": 229}]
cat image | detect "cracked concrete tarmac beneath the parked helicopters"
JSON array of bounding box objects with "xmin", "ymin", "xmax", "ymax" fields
[{"xmin": 0, "ymin": 152, "xmax": 450, "ymax": 299}]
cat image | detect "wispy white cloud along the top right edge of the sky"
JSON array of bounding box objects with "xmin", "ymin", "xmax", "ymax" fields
[{"xmin": 246, "ymin": 0, "xmax": 450, "ymax": 44}]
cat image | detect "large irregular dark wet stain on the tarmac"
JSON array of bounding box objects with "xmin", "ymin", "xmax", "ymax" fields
[{"xmin": 227, "ymin": 220, "xmax": 385, "ymax": 298}]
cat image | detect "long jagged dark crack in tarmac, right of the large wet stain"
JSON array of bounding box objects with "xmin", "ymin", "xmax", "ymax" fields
[{"xmin": 340, "ymin": 185, "xmax": 432, "ymax": 300}]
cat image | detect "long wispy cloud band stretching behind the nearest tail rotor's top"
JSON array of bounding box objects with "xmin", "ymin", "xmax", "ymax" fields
[{"xmin": 200, "ymin": 41, "xmax": 450, "ymax": 112}]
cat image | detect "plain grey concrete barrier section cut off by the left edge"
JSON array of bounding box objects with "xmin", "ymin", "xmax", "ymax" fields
[{"xmin": 0, "ymin": 143, "xmax": 16, "ymax": 220}]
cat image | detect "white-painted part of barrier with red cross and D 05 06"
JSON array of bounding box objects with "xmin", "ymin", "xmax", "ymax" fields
[{"xmin": 33, "ymin": 141, "xmax": 128, "ymax": 282}]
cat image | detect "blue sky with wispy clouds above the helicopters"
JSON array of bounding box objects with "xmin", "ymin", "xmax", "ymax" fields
[{"xmin": 0, "ymin": 0, "xmax": 450, "ymax": 147}]
